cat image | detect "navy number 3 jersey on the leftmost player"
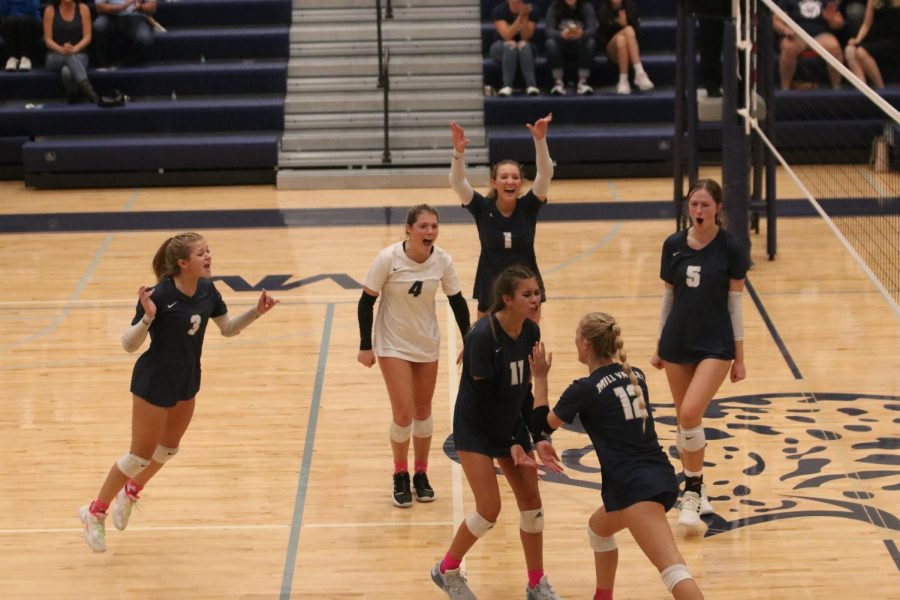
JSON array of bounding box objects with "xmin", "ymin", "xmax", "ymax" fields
[{"xmin": 131, "ymin": 277, "xmax": 228, "ymax": 407}]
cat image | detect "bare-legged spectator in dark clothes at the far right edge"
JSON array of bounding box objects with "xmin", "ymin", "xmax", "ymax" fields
[{"xmin": 844, "ymin": 0, "xmax": 900, "ymax": 88}]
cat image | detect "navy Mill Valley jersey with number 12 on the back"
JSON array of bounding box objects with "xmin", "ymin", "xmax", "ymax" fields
[{"xmin": 553, "ymin": 363, "xmax": 677, "ymax": 511}]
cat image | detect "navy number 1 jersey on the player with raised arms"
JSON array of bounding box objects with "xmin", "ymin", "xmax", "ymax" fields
[{"xmin": 466, "ymin": 190, "xmax": 547, "ymax": 310}]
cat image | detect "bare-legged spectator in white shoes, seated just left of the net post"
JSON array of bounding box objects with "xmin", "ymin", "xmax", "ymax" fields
[{"xmin": 597, "ymin": 0, "xmax": 653, "ymax": 94}]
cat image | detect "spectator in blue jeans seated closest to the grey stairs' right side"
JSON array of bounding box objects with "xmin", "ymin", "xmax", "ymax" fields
[{"xmin": 490, "ymin": 0, "xmax": 541, "ymax": 96}]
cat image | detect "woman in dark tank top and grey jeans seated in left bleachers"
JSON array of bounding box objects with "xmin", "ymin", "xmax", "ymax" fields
[{"xmin": 44, "ymin": 0, "xmax": 100, "ymax": 104}]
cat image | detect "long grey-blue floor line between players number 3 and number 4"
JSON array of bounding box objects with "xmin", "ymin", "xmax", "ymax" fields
[{"xmin": 279, "ymin": 302, "xmax": 334, "ymax": 600}]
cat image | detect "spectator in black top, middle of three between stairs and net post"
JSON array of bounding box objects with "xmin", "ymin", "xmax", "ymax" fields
[{"xmin": 545, "ymin": 0, "xmax": 597, "ymax": 96}]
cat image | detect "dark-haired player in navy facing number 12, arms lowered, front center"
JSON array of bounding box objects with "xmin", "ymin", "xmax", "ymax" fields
[{"xmin": 431, "ymin": 266, "xmax": 559, "ymax": 600}]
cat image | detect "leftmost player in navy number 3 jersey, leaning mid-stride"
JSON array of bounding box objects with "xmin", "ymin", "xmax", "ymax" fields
[{"xmin": 79, "ymin": 232, "xmax": 278, "ymax": 552}]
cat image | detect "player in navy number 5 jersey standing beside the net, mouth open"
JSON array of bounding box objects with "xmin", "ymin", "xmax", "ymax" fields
[{"xmin": 651, "ymin": 179, "xmax": 750, "ymax": 527}]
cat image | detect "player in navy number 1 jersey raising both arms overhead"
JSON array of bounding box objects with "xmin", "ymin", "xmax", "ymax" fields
[{"xmin": 450, "ymin": 114, "xmax": 553, "ymax": 321}]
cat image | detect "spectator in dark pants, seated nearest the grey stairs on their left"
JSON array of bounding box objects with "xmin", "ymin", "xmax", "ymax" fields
[{"xmin": 94, "ymin": 0, "xmax": 156, "ymax": 68}]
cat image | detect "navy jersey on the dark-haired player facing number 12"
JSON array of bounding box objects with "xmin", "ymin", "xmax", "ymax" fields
[{"xmin": 453, "ymin": 314, "xmax": 541, "ymax": 458}]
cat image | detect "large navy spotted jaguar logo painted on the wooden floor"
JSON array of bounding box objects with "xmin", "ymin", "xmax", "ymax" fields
[{"xmin": 444, "ymin": 393, "xmax": 900, "ymax": 536}]
